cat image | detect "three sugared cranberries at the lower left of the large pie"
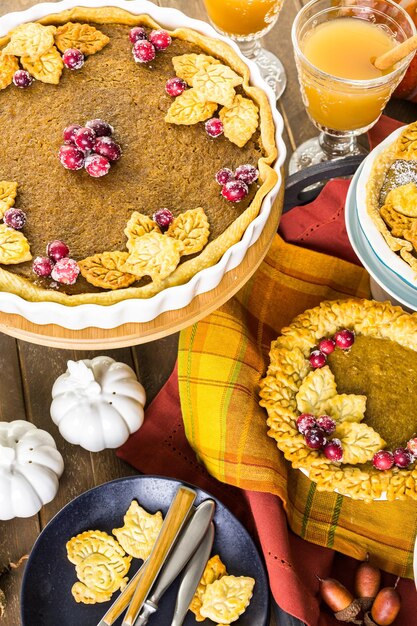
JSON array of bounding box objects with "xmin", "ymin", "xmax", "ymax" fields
[{"xmin": 32, "ymin": 239, "xmax": 80, "ymax": 285}]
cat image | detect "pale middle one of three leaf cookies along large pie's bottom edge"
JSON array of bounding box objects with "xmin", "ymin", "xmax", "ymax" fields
[{"xmin": 121, "ymin": 231, "xmax": 182, "ymax": 282}]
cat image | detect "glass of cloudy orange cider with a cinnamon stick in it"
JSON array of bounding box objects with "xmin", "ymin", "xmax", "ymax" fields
[{"xmin": 290, "ymin": 0, "xmax": 416, "ymax": 173}]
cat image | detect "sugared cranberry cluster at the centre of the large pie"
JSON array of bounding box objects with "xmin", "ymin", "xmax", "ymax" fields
[{"xmin": 59, "ymin": 119, "xmax": 122, "ymax": 178}]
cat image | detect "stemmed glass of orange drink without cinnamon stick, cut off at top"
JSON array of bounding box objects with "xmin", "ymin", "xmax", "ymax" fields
[{"xmin": 204, "ymin": 0, "xmax": 287, "ymax": 98}]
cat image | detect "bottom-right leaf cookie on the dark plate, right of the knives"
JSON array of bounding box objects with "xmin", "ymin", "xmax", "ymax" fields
[{"xmin": 200, "ymin": 576, "xmax": 255, "ymax": 624}]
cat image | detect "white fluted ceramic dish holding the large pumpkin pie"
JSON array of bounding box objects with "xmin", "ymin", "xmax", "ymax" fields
[{"xmin": 0, "ymin": 0, "xmax": 286, "ymax": 330}]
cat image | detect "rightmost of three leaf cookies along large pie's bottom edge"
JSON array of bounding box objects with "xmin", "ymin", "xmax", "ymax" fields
[{"xmin": 167, "ymin": 207, "xmax": 210, "ymax": 255}]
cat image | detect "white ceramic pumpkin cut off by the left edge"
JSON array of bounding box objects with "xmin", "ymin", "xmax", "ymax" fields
[{"xmin": 0, "ymin": 420, "xmax": 64, "ymax": 520}]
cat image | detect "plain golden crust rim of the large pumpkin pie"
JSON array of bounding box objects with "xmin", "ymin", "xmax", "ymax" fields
[{"xmin": 0, "ymin": 7, "xmax": 278, "ymax": 306}]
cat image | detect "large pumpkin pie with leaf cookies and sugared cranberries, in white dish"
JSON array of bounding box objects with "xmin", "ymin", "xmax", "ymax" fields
[{"xmin": 0, "ymin": 7, "xmax": 277, "ymax": 305}]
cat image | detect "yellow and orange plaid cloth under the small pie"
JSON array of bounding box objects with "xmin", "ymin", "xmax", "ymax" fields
[{"xmin": 178, "ymin": 235, "xmax": 417, "ymax": 578}]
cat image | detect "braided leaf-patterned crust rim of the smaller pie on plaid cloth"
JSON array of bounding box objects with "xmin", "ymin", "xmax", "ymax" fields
[{"xmin": 260, "ymin": 299, "xmax": 417, "ymax": 501}]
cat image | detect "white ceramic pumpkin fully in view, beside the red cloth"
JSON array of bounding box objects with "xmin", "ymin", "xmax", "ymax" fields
[{"xmin": 51, "ymin": 356, "xmax": 146, "ymax": 452}]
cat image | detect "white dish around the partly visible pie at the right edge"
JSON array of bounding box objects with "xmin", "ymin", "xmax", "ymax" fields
[{"xmin": 356, "ymin": 128, "xmax": 417, "ymax": 289}]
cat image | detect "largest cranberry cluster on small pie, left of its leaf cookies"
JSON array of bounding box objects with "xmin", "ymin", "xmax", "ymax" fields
[{"xmin": 297, "ymin": 413, "xmax": 343, "ymax": 461}]
